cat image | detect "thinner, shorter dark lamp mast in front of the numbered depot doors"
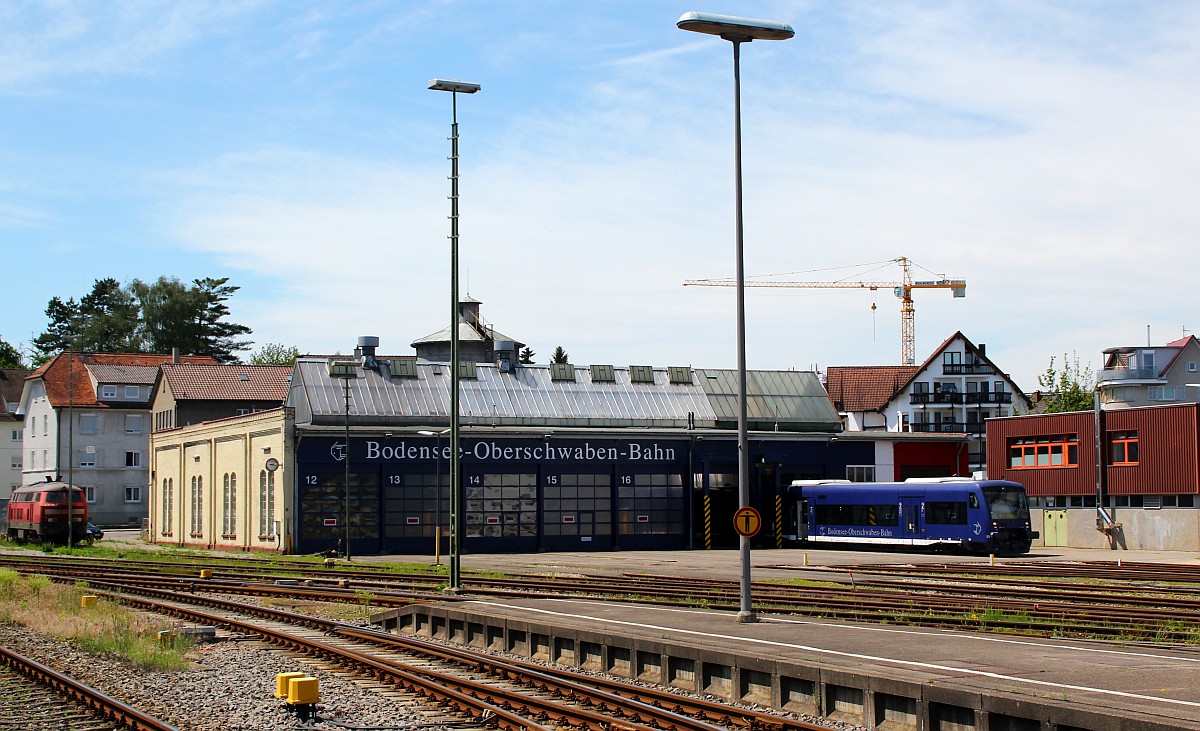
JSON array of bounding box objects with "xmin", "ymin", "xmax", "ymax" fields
[{"xmin": 430, "ymin": 79, "xmax": 480, "ymax": 592}]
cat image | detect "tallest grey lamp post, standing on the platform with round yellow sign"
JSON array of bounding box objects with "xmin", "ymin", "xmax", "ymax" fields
[{"xmin": 676, "ymin": 12, "xmax": 796, "ymax": 623}]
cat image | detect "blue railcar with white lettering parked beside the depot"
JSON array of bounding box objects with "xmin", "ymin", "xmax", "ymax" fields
[{"xmin": 787, "ymin": 478, "xmax": 1038, "ymax": 555}]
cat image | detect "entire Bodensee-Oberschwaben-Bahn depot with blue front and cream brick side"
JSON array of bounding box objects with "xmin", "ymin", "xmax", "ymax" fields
[{"xmin": 149, "ymin": 302, "xmax": 967, "ymax": 555}]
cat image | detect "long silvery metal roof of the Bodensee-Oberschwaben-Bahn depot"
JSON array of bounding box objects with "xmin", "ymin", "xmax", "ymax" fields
[{"xmin": 288, "ymin": 359, "xmax": 841, "ymax": 431}]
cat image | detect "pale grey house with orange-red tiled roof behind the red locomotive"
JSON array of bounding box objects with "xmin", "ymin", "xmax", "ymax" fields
[{"xmin": 17, "ymin": 353, "xmax": 216, "ymax": 526}]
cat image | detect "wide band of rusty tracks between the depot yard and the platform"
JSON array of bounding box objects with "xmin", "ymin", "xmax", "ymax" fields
[{"xmin": 7, "ymin": 557, "xmax": 1200, "ymax": 645}]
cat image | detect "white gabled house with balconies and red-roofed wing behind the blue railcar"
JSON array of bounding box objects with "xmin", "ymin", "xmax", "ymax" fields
[{"xmin": 826, "ymin": 331, "xmax": 1031, "ymax": 472}]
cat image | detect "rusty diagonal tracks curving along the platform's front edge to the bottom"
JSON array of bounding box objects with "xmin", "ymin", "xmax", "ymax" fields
[{"xmin": 75, "ymin": 582, "xmax": 828, "ymax": 731}]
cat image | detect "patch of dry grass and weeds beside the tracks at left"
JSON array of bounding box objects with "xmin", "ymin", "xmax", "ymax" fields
[{"xmin": 0, "ymin": 569, "xmax": 191, "ymax": 670}]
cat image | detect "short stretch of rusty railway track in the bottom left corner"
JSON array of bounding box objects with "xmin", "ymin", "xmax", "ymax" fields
[{"xmin": 0, "ymin": 646, "xmax": 176, "ymax": 731}]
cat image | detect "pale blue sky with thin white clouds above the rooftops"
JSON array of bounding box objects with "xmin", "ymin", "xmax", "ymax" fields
[{"xmin": 0, "ymin": 0, "xmax": 1200, "ymax": 391}]
